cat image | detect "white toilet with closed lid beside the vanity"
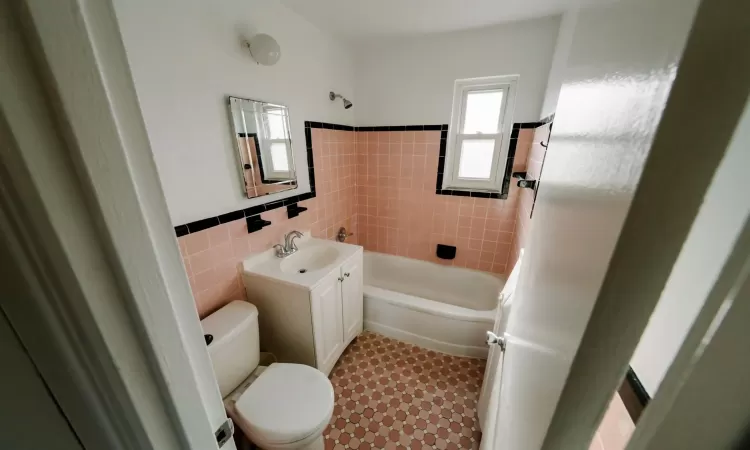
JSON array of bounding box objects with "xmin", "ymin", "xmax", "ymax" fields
[{"xmin": 201, "ymin": 300, "xmax": 334, "ymax": 450}]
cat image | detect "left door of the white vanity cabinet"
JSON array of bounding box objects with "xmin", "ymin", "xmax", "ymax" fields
[{"xmin": 311, "ymin": 272, "xmax": 344, "ymax": 374}]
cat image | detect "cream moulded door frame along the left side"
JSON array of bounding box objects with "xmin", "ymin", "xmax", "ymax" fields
[{"xmin": 0, "ymin": 0, "xmax": 234, "ymax": 450}]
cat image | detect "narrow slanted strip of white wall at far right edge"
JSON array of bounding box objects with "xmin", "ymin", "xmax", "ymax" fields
[{"xmin": 630, "ymin": 97, "xmax": 750, "ymax": 396}]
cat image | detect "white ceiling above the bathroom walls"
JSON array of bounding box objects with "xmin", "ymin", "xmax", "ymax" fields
[{"xmin": 281, "ymin": 0, "xmax": 611, "ymax": 40}]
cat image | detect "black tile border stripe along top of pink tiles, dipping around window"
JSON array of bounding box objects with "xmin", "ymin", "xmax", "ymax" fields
[{"xmin": 174, "ymin": 118, "xmax": 555, "ymax": 237}]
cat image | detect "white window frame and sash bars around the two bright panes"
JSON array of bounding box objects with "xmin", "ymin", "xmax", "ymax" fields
[{"xmin": 442, "ymin": 75, "xmax": 519, "ymax": 193}]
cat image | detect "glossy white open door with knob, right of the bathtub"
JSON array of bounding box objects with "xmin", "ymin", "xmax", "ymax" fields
[{"xmin": 482, "ymin": 0, "xmax": 695, "ymax": 450}]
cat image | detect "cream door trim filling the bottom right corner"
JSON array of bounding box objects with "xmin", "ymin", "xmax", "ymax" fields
[{"xmin": 627, "ymin": 216, "xmax": 750, "ymax": 450}]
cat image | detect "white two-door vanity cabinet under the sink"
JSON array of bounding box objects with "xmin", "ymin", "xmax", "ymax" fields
[{"xmin": 243, "ymin": 243, "xmax": 363, "ymax": 374}]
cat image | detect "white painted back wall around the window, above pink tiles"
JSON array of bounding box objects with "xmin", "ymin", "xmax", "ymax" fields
[{"xmin": 353, "ymin": 16, "xmax": 560, "ymax": 126}]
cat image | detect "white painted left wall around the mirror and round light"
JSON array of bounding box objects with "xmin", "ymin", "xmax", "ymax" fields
[{"xmin": 114, "ymin": 0, "xmax": 357, "ymax": 225}]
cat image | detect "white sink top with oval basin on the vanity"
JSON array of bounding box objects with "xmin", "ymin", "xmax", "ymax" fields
[{"xmin": 242, "ymin": 232, "xmax": 362, "ymax": 289}]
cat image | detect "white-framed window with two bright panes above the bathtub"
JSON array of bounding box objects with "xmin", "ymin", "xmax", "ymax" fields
[{"xmin": 443, "ymin": 75, "xmax": 518, "ymax": 192}]
